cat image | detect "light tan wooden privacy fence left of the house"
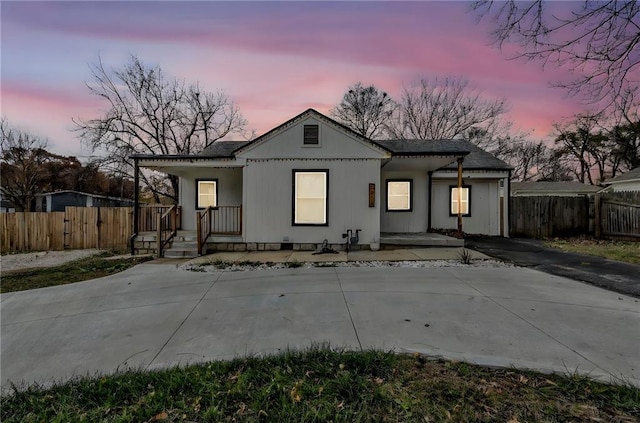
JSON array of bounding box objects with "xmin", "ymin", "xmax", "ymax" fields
[{"xmin": 0, "ymin": 207, "xmax": 133, "ymax": 253}]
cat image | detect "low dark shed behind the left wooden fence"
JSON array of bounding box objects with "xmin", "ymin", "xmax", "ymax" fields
[{"xmin": 35, "ymin": 190, "xmax": 133, "ymax": 212}]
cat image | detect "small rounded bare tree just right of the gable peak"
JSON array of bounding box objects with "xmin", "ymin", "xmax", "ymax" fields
[{"xmin": 330, "ymin": 82, "xmax": 397, "ymax": 139}]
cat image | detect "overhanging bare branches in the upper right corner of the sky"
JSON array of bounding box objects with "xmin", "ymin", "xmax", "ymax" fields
[{"xmin": 472, "ymin": 0, "xmax": 640, "ymax": 112}]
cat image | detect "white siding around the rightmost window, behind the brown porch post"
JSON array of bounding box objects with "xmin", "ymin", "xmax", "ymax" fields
[{"xmin": 431, "ymin": 178, "xmax": 500, "ymax": 235}]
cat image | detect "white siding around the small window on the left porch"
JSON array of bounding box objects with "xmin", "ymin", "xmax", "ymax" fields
[{"xmin": 180, "ymin": 167, "xmax": 242, "ymax": 231}]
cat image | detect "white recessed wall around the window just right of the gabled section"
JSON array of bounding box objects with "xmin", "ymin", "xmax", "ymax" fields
[{"xmin": 380, "ymin": 169, "xmax": 429, "ymax": 233}]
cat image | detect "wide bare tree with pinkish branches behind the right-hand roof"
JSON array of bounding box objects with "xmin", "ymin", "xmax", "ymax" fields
[{"xmin": 393, "ymin": 77, "xmax": 507, "ymax": 139}]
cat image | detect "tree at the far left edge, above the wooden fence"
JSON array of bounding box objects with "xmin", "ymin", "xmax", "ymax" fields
[{"xmin": 0, "ymin": 118, "xmax": 51, "ymax": 211}]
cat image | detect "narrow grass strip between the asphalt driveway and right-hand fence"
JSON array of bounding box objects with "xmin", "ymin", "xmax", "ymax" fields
[{"xmin": 546, "ymin": 237, "xmax": 640, "ymax": 264}]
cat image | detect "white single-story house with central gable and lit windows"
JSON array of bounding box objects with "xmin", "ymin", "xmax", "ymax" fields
[{"xmin": 132, "ymin": 109, "xmax": 511, "ymax": 255}]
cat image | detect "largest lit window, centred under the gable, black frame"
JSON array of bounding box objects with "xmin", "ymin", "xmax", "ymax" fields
[{"xmin": 292, "ymin": 170, "xmax": 329, "ymax": 226}]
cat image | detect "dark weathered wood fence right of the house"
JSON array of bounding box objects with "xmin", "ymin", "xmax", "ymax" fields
[{"xmin": 510, "ymin": 192, "xmax": 640, "ymax": 240}]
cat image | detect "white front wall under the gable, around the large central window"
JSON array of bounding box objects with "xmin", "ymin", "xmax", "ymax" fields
[{"xmin": 244, "ymin": 159, "xmax": 380, "ymax": 244}]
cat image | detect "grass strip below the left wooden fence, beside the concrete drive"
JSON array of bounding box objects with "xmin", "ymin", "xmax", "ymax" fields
[{"xmin": 0, "ymin": 252, "xmax": 151, "ymax": 293}]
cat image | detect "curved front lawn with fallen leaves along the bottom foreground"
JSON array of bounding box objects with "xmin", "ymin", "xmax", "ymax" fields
[{"xmin": 0, "ymin": 348, "xmax": 640, "ymax": 423}]
